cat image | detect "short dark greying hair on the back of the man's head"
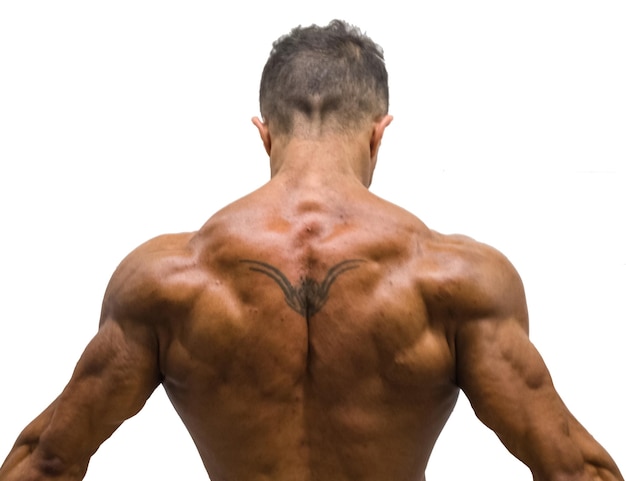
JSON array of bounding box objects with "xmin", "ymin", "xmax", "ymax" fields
[{"xmin": 259, "ymin": 20, "xmax": 389, "ymax": 134}]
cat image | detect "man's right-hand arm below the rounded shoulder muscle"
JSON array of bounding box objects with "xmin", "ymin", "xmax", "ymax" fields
[{"xmin": 456, "ymin": 320, "xmax": 622, "ymax": 480}]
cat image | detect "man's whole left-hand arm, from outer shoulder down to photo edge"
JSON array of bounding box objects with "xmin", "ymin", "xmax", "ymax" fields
[{"xmin": 0, "ymin": 246, "xmax": 160, "ymax": 481}]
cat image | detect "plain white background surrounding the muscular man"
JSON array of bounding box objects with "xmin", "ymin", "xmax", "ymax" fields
[{"xmin": 0, "ymin": 0, "xmax": 626, "ymax": 481}]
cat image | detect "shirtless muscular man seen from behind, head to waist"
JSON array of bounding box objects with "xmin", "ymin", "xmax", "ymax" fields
[{"xmin": 0, "ymin": 18, "xmax": 623, "ymax": 481}]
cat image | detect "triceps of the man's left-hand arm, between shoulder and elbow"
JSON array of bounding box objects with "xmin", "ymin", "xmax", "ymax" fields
[{"xmin": 30, "ymin": 320, "xmax": 160, "ymax": 469}]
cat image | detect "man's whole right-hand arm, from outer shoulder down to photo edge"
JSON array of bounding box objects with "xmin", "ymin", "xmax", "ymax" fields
[{"xmin": 455, "ymin": 247, "xmax": 623, "ymax": 480}]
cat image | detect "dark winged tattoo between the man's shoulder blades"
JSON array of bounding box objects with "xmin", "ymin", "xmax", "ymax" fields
[{"xmin": 240, "ymin": 259, "xmax": 365, "ymax": 320}]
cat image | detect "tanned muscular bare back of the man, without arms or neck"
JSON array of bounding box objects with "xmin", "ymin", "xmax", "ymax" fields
[{"xmin": 139, "ymin": 181, "xmax": 457, "ymax": 481}]
